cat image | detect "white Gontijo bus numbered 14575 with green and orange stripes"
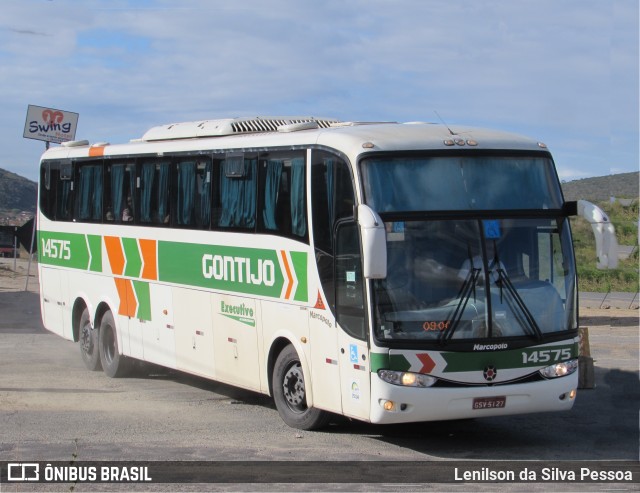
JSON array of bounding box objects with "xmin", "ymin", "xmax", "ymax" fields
[{"xmin": 38, "ymin": 117, "xmax": 578, "ymax": 429}]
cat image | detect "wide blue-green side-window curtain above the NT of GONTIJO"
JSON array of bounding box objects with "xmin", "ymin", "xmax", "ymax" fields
[{"xmin": 220, "ymin": 159, "xmax": 257, "ymax": 228}]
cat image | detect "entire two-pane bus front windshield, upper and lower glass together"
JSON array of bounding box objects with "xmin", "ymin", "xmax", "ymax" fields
[{"xmin": 361, "ymin": 156, "xmax": 577, "ymax": 344}]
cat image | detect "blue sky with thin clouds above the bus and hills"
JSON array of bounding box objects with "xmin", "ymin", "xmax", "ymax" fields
[{"xmin": 0, "ymin": 0, "xmax": 639, "ymax": 180}]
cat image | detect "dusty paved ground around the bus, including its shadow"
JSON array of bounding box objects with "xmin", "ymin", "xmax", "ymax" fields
[{"xmin": 0, "ymin": 268, "xmax": 640, "ymax": 491}]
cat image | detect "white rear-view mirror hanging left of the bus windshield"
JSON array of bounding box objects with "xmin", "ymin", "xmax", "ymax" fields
[{"xmin": 358, "ymin": 205, "xmax": 387, "ymax": 279}]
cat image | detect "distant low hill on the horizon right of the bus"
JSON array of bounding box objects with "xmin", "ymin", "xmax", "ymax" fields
[{"xmin": 562, "ymin": 171, "xmax": 640, "ymax": 202}]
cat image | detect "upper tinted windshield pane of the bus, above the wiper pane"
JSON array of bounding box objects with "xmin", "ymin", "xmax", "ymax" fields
[{"xmin": 360, "ymin": 154, "xmax": 562, "ymax": 213}]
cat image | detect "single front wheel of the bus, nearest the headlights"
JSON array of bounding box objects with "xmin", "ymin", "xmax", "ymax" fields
[{"xmin": 272, "ymin": 345, "xmax": 330, "ymax": 430}]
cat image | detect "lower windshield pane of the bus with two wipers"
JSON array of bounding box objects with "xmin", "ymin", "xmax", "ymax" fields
[{"xmin": 374, "ymin": 218, "xmax": 577, "ymax": 343}]
